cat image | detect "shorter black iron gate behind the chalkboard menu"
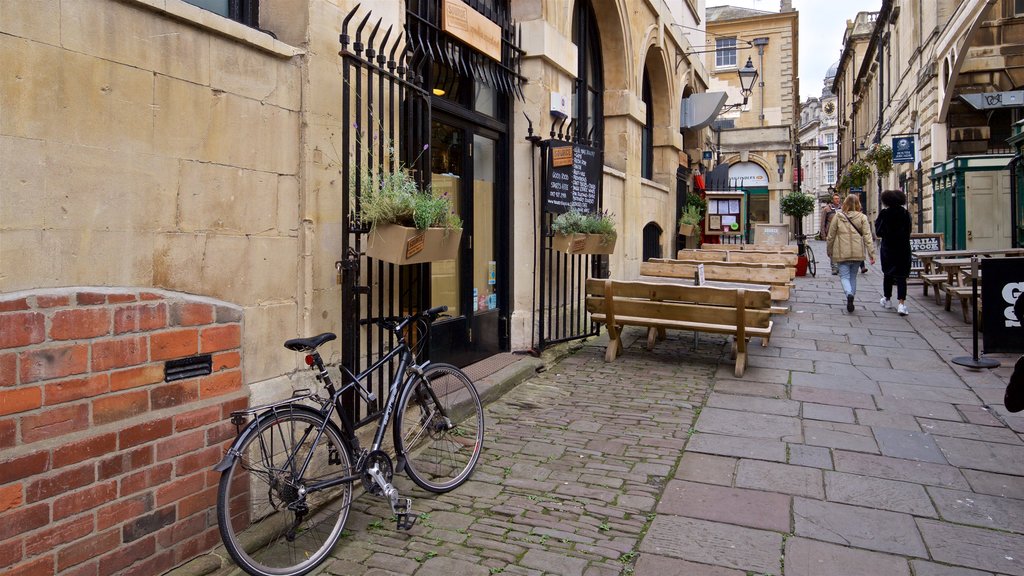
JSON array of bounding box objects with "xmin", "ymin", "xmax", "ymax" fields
[{"xmin": 537, "ymin": 121, "xmax": 608, "ymax": 349}]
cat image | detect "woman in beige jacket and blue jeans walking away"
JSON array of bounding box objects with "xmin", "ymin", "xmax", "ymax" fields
[{"xmin": 827, "ymin": 194, "xmax": 874, "ymax": 313}]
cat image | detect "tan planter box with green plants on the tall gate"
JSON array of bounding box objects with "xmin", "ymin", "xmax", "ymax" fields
[{"xmin": 359, "ymin": 168, "xmax": 462, "ymax": 264}]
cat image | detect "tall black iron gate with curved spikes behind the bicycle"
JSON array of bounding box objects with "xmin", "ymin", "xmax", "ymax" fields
[{"xmin": 338, "ymin": 6, "xmax": 430, "ymax": 424}]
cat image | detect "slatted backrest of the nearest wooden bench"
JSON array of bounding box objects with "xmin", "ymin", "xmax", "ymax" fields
[{"xmin": 587, "ymin": 278, "xmax": 772, "ymax": 328}]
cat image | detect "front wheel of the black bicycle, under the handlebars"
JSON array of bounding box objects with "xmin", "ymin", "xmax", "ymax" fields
[{"xmin": 394, "ymin": 364, "xmax": 483, "ymax": 493}]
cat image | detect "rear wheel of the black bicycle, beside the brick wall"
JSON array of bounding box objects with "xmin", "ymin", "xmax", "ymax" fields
[{"xmin": 217, "ymin": 407, "xmax": 352, "ymax": 576}]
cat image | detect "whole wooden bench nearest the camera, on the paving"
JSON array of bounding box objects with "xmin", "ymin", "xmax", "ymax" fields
[{"xmin": 587, "ymin": 278, "xmax": 772, "ymax": 377}]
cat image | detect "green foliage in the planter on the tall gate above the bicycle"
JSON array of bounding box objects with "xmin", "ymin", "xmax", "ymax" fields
[{"xmin": 351, "ymin": 168, "xmax": 462, "ymax": 231}]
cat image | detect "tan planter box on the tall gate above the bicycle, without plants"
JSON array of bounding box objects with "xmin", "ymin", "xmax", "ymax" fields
[{"xmin": 367, "ymin": 224, "xmax": 462, "ymax": 264}]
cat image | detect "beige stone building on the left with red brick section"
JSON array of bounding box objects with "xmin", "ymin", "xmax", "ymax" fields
[{"xmin": 0, "ymin": 0, "xmax": 716, "ymax": 574}]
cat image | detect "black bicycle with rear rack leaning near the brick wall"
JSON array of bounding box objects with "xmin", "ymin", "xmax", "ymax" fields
[{"xmin": 214, "ymin": 306, "xmax": 483, "ymax": 576}]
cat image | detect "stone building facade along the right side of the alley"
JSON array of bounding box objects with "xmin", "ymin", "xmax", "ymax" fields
[{"xmin": 835, "ymin": 0, "xmax": 1024, "ymax": 242}]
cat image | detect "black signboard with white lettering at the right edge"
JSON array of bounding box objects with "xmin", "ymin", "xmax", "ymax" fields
[{"xmin": 979, "ymin": 258, "xmax": 1024, "ymax": 354}]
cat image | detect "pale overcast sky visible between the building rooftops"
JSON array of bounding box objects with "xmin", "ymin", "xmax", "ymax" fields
[{"xmin": 708, "ymin": 0, "xmax": 882, "ymax": 100}]
